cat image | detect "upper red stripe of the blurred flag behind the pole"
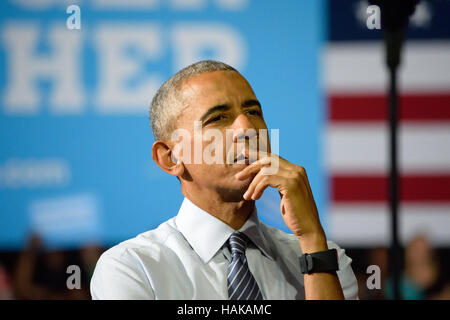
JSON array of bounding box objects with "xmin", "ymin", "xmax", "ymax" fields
[{"xmin": 328, "ymin": 93, "xmax": 450, "ymax": 122}]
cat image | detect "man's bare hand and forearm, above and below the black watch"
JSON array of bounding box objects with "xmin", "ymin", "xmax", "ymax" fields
[{"xmin": 236, "ymin": 154, "xmax": 344, "ymax": 300}]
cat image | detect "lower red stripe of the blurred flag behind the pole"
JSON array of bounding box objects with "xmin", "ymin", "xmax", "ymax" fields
[{"xmin": 331, "ymin": 175, "xmax": 450, "ymax": 202}]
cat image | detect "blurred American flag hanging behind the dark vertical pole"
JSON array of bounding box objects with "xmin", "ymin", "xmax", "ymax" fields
[{"xmin": 323, "ymin": 0, "xmax": 450, "ymax": 247}]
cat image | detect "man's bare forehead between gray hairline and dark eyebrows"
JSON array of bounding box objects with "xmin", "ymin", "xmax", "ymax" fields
[{"xmin": 180, "ymin": 70, "xmax": 255, "ymax": 109}]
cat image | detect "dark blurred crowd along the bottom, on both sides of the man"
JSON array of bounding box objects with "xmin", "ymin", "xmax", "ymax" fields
[{"xmin": 0, "ymin": 235, "xmax": 450, "ymax": 300}]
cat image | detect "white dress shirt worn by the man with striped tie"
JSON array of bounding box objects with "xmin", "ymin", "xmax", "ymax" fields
[{"xmin": 91, "ymin": 198, "xmax": 358, "ymax": 300}]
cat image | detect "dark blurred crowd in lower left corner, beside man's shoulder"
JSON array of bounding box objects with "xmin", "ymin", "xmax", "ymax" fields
[{"xmin": 0, "ymin": 234, "xmax": 104, "ymax": 300}]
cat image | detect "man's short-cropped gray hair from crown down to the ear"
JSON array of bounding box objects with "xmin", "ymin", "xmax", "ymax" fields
[{"xmin": 150, "ymin": 60, "xmax": 239, "ymax": 140}]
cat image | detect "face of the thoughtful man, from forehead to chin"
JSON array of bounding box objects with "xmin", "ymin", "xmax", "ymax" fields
[{"xmin": 176, "ymin": 71, "xmax": 270, "ymax": 200}]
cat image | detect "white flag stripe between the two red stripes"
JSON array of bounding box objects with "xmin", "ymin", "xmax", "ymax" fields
[{"xmin": 325, "ymin": 123, "xmax": 450, "ymax": 175}]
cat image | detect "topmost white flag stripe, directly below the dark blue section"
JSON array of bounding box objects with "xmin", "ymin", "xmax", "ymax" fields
[{"xmin": 323, "ymin": 41, "xmax": 450, "ymax": 93}]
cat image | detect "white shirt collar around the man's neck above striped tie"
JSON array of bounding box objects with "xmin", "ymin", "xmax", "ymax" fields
[{"xmin": 175, "ymin": 197, "xmax": 273, "ymax": 263}]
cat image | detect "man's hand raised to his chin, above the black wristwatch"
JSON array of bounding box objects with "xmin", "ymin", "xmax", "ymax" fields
[{"xmin": 235, "ymin": 154, "xmax": 326, "ymax": 252}]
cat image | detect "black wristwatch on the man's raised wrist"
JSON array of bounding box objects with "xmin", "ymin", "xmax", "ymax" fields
[{"xmin": 300, "ymin": 249, "xmax": 339, "ymax": 274}]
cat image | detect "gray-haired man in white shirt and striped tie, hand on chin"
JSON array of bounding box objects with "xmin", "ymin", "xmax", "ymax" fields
[{"xmin": 91, "ymin": 60, "xmax": 357, "ymax": 299}]
